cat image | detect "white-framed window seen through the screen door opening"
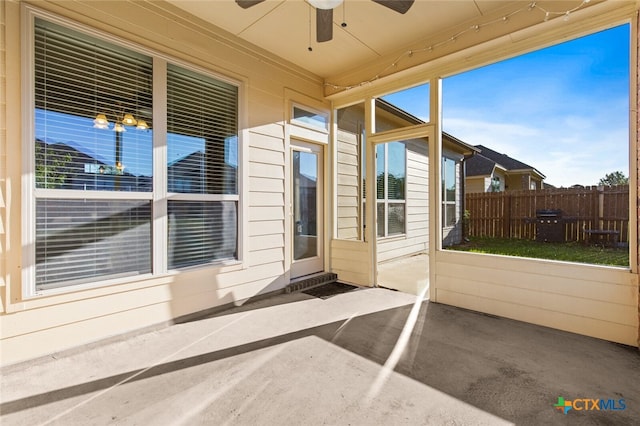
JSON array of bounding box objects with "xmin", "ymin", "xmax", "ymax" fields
[{"xmin": 376, "ymin": 142, "xmax": 406, "ymax": 237}]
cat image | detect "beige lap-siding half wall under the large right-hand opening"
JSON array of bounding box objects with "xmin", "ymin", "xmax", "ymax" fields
[{"xmin": 434, "ymin": 251, "xmax": 638, "ymax": 346}]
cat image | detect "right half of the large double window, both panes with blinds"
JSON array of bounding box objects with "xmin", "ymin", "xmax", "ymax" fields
[{"xmin": 167, "ymin": 64, "xmax": 239, "ymax": 268}]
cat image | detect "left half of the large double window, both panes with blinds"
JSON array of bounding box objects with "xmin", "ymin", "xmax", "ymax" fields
[{"xmin": 33, "ymin": 19, "xmax": 153, "ymax": 290}]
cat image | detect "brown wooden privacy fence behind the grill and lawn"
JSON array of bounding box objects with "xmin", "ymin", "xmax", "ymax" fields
[{"xmin": 464, "ymin": 185, "xmax": 629, "ymax": 242}]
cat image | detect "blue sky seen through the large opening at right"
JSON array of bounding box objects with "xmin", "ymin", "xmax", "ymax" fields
[{"xmin": 442, "ymin": 25, "xmax": 630, "ymax": 187}]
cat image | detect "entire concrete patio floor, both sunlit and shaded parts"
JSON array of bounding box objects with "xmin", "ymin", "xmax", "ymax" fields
[{"xmin": 0, "ymin": 288, "xmax": 640, "ymax": 426}]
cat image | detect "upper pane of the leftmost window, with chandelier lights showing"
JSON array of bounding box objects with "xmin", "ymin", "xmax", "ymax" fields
[{"xmin": 35, "ymin": 19, "xmax": 152, "ymax": 192}]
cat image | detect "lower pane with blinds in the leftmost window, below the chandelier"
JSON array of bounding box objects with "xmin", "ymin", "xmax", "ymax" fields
[{"xmin": 36, "ymin": 199, "xmax": 151, "ymax": 290}]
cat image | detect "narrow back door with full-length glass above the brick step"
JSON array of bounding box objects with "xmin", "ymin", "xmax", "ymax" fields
[{"xmin": 291, "ymin": 141, "xmax": 324, "ymax": 278}]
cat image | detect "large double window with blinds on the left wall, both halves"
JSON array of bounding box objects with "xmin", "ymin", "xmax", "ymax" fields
[{"xmin": 25, "ymin": 17, "xmax": 239, "ymax": 292}]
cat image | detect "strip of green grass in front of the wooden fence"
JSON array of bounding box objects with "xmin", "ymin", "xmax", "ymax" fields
[{"xmin": 448, "ymin": 237, "xmax": 629, "ymax": 267}]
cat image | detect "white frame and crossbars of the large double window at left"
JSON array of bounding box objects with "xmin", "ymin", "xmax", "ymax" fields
[{"xmin": 21, "ymin": 5, "xmax": 248, "ymax": 300}]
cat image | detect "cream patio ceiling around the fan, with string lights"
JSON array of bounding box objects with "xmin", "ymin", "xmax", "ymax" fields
[{"xmin": 168, "ymin": 0, "xmax": 601, "ymax": 84}]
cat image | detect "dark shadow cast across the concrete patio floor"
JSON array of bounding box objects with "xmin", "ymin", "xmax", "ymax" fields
[{"xmin": 0, "ymin": 294, "xmax": 640, "ymax": 424}]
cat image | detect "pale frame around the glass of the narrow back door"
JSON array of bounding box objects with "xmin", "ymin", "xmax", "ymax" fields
[{"xmin": 288, "ymin": 138, "xmax": 326, "ymax": 280}]
